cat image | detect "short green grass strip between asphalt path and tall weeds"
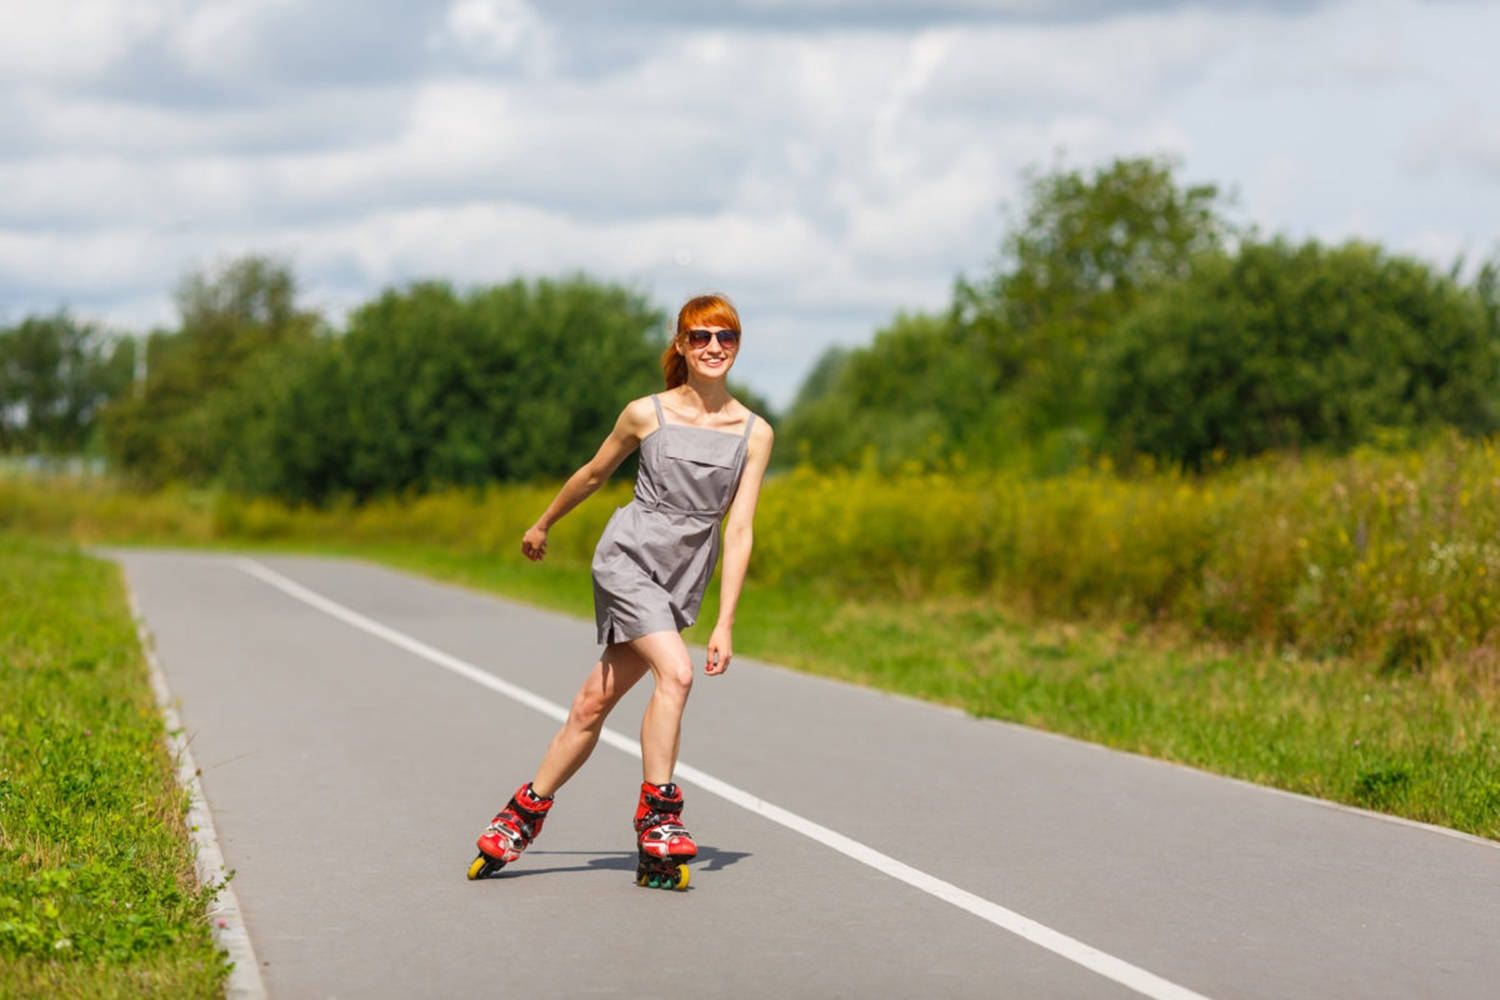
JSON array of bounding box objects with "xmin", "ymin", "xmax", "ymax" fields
[{"xmin": 344, "ymin": 547, "xmax": 1500, "ymax": 840}]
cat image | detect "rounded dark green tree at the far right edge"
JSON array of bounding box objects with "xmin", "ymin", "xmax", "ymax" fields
[{"xmin": 1103, "ymin": 240, "xmax": 1500, "ymax": 468}]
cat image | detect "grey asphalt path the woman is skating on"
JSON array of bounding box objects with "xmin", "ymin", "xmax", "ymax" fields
[{"xmin": 111, "ymin": 550, "xmax": 1500, "ymax": 999}]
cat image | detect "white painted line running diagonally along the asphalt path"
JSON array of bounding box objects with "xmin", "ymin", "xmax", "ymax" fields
[{"xmin": 234, "ymin": 558, "xmax": 1206, "ymax": 1000}]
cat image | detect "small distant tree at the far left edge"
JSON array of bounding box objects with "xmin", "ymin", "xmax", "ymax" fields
[{"xmin": 0, "ymin": 312, "xmax": 135, "ymax": 454}]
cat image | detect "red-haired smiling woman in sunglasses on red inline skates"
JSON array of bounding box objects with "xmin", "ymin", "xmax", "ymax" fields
[{"xmin": 470, "ymin": 295, "xmax": 773, "ymax": 889}]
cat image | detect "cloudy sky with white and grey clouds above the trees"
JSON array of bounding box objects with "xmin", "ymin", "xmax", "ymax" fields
[{"xmin": 0, "ymin": 0, "xmax": 1500, "ymax": 406}]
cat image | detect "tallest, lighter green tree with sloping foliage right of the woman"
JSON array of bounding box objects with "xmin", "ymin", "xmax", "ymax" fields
[{"xmin": 779, "ymin": 159, "xmax": 1230, "ymax": 472}]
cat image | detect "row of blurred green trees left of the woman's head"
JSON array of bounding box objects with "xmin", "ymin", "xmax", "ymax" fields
[{"xmin": 0, "ymin": 256, "xmax": 765, "ymax": 504}]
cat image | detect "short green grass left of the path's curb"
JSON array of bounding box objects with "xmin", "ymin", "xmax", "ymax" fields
[{"xmin": 0, "ymin": 534, "xmax": 228, "ymax": 997}]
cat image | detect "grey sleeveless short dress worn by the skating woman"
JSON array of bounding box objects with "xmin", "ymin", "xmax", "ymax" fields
[{"xmin": 594, "ymin": 396, "xmax": 755, "ymax": 643}]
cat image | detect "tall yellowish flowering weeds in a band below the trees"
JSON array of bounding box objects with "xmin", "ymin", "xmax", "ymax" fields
[{"xmin": 0, "ymin": 435, "xmax": 1500, "ymax": 682}]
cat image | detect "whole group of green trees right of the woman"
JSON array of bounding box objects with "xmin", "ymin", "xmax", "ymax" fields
[{"xmin": 782, "ymin": 159, "xmax": 1500, "ymax": 474}]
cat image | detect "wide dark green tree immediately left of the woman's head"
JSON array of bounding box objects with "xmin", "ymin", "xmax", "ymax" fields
[{"xmin": 230, "ymin": 276, "xmax": 665, "ymax": 502}]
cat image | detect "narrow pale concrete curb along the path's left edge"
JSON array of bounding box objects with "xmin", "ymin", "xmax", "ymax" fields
[{"xmin": 120, "ymin": 587, "xmax": 269, "ymax": 1000}]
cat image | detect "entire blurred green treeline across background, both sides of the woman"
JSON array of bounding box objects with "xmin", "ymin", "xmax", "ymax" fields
[{"xmin": 0, "ymin": 159, "xmax": 1500, "ymax": 494}]
